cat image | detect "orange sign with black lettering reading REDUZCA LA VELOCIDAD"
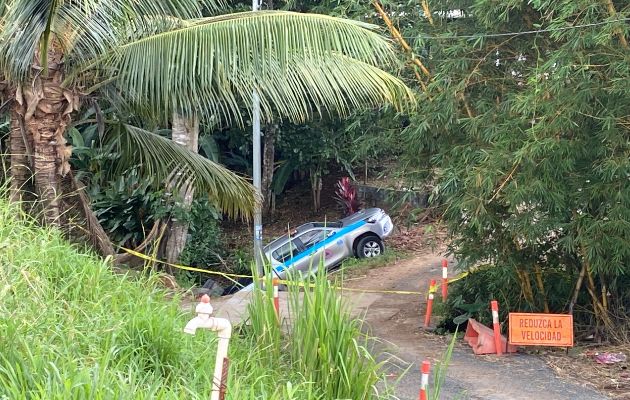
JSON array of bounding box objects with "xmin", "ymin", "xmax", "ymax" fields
[{"xmin": 510, "ymin": 313, "xmax": 573, "ymax": 347}]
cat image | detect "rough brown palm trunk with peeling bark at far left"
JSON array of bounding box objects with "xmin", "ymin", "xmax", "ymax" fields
[{"xmin": 11, "ymin": 51, "xmax": 79, "ymax": 225}]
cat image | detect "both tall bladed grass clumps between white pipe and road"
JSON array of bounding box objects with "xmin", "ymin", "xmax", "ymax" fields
[{"xmin": 249, "ymin": 267, "xmax": 385, "ymax": 400}]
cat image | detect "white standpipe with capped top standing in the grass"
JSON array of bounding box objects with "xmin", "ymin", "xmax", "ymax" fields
[{"xmin": 184, "ymin": 295, "xmax": 232, "ymax": 400}]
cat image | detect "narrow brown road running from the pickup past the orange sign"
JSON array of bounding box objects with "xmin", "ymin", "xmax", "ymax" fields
[{"xmin": 346, "ymin": 253, "xmax": 608, "ymax": 400}]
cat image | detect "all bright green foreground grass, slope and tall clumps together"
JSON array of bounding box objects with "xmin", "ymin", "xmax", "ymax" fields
[{"xmin": 0, "ymin": 199, "xmax": 392, "ymax": 400}]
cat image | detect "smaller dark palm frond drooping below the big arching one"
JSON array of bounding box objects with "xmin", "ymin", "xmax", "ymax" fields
[{"xmin": 109, "ymin": 124, "xmax": 258, "ymax": 218}]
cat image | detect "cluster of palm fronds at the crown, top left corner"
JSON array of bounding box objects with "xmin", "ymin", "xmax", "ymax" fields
[{"xmin": 0, "ymin": 0, "xmax": 222, "ymax": 79}]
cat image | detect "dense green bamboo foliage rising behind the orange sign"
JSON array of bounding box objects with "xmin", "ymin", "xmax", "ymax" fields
[{"xmin": 401, "ymin": 0, "xmax": 630, "ymax": 332}]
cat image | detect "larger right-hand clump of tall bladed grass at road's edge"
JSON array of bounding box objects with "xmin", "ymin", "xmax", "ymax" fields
[{"xmin": 289, "ymin": 266, "xmax": 381, "ymax": 400}]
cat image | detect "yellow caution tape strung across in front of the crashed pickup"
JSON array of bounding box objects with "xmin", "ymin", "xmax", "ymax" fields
[{"xmin": 120, "ymin": 247, "xmax": 469, "ymax": 296}]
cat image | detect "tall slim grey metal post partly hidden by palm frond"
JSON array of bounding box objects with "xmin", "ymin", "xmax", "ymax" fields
[{"xmin": 252, "ymin": 0, "xmax": 264, "ymax": 277}]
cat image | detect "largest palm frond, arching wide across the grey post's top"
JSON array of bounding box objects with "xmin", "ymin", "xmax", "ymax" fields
[{"xmin": 108, "ymin": 11, "xmax": 410, "ymax": 122}]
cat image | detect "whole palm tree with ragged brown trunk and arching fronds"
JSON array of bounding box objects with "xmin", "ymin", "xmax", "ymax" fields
[{"xmin": 0, "ymin": 0, "xmax": 411, "ymax": 253}]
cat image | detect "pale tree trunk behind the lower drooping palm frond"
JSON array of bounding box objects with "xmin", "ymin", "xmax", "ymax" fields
[{"xmin": 164, "ymin": 114, "xmax": 199, "ymax": 263}]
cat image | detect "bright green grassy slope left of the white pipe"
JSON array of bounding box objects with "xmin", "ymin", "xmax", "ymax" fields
[{"xmin": 0, "ymin": 200, "xmax": 225, "ymax": 399}]
